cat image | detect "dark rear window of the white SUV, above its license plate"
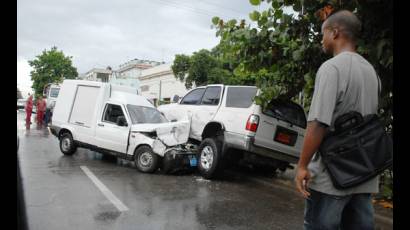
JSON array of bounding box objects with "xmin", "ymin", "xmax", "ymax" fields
[{"xmin": 263, "ymin": 99, "xmax": 306, "ymax": 128}]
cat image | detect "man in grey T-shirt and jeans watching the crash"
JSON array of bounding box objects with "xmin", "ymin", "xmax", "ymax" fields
[{"xmin": 295, "ymin": 10, "xmax": 380, "ymax": 230}]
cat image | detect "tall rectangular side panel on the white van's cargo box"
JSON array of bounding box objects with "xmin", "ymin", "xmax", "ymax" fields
[{"xmin": 68, "ymin": 85, "xmax": 100, "ymax": 144}]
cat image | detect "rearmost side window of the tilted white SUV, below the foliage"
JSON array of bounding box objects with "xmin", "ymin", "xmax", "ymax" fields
[{"xmin": 226, "ymin": 87, "xmax": 257, "ymax": 108}]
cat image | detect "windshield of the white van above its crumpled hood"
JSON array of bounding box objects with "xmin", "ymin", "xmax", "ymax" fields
[{"xmin": 127, "ymin": 104, "xmax": 168, "ymax": 124}]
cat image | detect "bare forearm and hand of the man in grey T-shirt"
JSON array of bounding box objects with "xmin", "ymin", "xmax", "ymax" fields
[{"xmin": 295, "ymin": 121, "xmax": 326, "ymax": 198}]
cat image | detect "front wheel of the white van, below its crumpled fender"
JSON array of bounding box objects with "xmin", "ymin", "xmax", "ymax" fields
[{"xmin": 134, "ymin": 145, "xmax": 159, "ymax": 173}]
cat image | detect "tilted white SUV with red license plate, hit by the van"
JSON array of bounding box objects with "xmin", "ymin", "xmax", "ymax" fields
[{"xmin": 158, "ymin": 85, "xmax": 306, "ymax": 179}]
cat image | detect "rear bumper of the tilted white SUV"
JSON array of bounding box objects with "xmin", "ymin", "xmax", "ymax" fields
[{"xmin": 224, "ymin": 132, "xmax": 299, "ymax": 164}]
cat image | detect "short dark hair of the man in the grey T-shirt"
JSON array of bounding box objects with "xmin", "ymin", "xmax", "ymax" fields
[{"xmin": 326, "ymin": 10, "xmax": 362, "ymax": 42}]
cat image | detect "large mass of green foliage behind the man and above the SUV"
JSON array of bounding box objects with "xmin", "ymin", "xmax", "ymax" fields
[{"xmin": 173, "ymin": 0, "xmax": 393, "ymax": 131}]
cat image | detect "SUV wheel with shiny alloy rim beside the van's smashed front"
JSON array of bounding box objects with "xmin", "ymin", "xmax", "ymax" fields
[{"xmin": 197, "ymin": 138, "xmax": 223, "ymax": 179}]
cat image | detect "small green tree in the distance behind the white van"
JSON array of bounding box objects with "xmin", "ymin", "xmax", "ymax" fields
[{"xmin": 28, "ymin": 46, "xmax": 78, "ymax": 95}]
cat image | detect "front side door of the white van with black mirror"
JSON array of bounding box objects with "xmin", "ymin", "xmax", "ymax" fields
[{"xmin": 95, "ymin": 102, "xmax": 131, "ymax": 153}]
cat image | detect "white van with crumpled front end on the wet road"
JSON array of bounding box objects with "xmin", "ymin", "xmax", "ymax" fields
[{"xmin": 50, "ymin": 80, "xmax": 196, "ymax": 172}]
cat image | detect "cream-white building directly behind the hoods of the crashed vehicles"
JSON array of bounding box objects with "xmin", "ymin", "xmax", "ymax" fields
[{"xmin": 139, "ymin": 63, "xmax": 188, "ymax": 105}]
